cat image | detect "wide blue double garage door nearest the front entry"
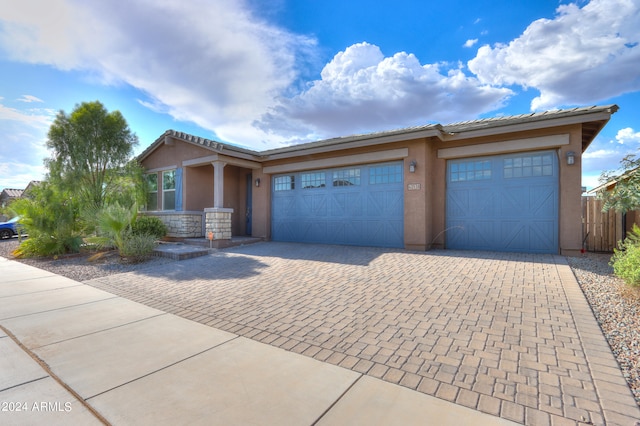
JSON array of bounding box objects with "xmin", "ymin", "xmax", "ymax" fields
[{"xmin": 271, "ymin": 162, "xmax": 404, "ymax": 247}]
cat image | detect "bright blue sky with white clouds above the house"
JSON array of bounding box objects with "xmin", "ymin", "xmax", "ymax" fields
[{"xmin": 0, "ymin": 0, "xmax": 640, "ymax": 189}]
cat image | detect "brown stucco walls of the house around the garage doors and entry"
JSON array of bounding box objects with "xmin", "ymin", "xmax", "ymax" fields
[{"xmin": 144, "ymin": 117, "xmax": 604, "ymax": 254}]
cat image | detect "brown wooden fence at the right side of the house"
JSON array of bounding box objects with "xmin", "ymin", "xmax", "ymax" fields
[{"xmin": 582, "ymin": 197, "xmax": 626, "ymax": 252}]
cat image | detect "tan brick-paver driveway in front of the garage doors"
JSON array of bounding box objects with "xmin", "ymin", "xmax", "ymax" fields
[{"xmin": 87, "ymin": 243, "xmax": 638, "ymax": 425}]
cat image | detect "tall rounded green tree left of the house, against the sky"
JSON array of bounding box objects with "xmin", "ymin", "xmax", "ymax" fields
[{"xmin": 45, "ymin": 101, "xmax": 138, "ymax": 208}]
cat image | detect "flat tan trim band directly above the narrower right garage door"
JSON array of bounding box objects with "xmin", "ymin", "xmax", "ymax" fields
[{"xmin": 438, "ymin": 133, "xmax": 570, "ymax": 159}]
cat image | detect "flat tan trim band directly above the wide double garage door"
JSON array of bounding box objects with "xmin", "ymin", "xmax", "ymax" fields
[{"xmin": 262, "ymin": 148, "xmax": 409, "ymax": 174}]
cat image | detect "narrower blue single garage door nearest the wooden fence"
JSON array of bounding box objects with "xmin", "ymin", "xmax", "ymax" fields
[{"xmin": 446, "ymin": 151, "xmax": 558, "ymax": 253}]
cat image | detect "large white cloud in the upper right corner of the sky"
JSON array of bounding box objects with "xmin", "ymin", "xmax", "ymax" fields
[{"xmin": 468, "ymin": 0, "xmax": 640, "ymax": 110}]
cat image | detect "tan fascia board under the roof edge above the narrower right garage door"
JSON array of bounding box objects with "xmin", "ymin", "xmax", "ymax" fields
[{"xmin": 444, "ymin": 112, "xmax": 611, "ymax": 141}]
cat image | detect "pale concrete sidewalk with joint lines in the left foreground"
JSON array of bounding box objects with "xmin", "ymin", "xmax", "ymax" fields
[{"xmin": 0, "ymin": 258, "xmax": 513, "ymax": 426}]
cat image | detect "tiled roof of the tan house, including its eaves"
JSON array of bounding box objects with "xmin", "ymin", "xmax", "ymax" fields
[{"xmin": 138, "ymin": 105, "xmax": 618, "ymax": 161}]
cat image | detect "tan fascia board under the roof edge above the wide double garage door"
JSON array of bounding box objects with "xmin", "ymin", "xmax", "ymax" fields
[{"xmin": 264, "ymin": 129, "xmax": 442, "ymax": 160}]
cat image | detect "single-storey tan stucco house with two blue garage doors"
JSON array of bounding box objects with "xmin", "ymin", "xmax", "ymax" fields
[{"xmin": 138, "ymin": 105, "xmax": 618, "ymax": 254}]
